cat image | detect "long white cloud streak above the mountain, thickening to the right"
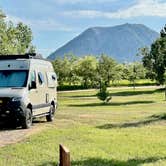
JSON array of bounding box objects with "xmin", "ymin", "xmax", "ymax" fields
[{"xmin": 64, "ymin": 0, "xmax": 166, "ymax": 19}]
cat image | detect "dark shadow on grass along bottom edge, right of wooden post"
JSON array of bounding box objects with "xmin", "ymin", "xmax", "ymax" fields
[{"xmin": 71, "ymin": 157, "xmax": 166, "ymax": 166}]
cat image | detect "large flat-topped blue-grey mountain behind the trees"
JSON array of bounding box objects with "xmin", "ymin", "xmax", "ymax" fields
[{"xmin": 48, "ymin": 23, "xmax": 159, "ymax": 62}]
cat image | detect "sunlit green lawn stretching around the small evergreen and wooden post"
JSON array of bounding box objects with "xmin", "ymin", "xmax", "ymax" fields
[{"xmin": 0, "ymin": 88, "xmax": 166, "ymax": 166}]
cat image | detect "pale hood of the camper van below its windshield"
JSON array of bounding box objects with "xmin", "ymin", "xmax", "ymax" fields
[{"xmin": 0, "ymin": 88, "xmax": 27, "ymax": 97}]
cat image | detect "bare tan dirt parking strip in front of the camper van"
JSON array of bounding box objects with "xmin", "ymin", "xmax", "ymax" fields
[{"xmin": 0, "ymin": 121, "xmax": 48, "ymax": 147}]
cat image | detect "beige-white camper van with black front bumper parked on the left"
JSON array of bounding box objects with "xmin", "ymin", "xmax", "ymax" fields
[{"xmin": 0, "ymin": 54, "xmax": 57, "ymax": 129}]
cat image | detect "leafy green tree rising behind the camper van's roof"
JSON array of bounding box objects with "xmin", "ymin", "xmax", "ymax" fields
[{"xmin": 0, "ymin": 9, "xmax": 35, "ymax": 55}]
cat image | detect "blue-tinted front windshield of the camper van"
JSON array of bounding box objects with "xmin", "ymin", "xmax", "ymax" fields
[{"xmin": 0, "ymin": 70, "xmax": 28, "ymax": 88}]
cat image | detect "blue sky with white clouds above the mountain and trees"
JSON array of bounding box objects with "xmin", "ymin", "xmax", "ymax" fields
[{"xmin": 0, "ymin": 0, "xmax": 166, "ymax": 57}]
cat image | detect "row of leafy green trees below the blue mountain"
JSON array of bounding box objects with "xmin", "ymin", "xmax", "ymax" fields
[{"xmin": 52, "ymin": 54, "xmax": 147, "ymax": 88}]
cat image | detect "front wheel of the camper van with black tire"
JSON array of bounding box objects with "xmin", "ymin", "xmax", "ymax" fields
[{"xmin": 22, "ymin": 108, "xmax": 32, "ymax": 129}]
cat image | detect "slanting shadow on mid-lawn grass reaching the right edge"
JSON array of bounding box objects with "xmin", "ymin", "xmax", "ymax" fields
[{"xmin": 97, "ymin": 113, "xmax": 166, "ymax": 129}]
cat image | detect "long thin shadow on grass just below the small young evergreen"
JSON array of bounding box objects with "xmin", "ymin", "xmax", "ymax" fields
[{"xmin": 68, "ymin": 101, "xmax": 154, "ymax": 107}]
